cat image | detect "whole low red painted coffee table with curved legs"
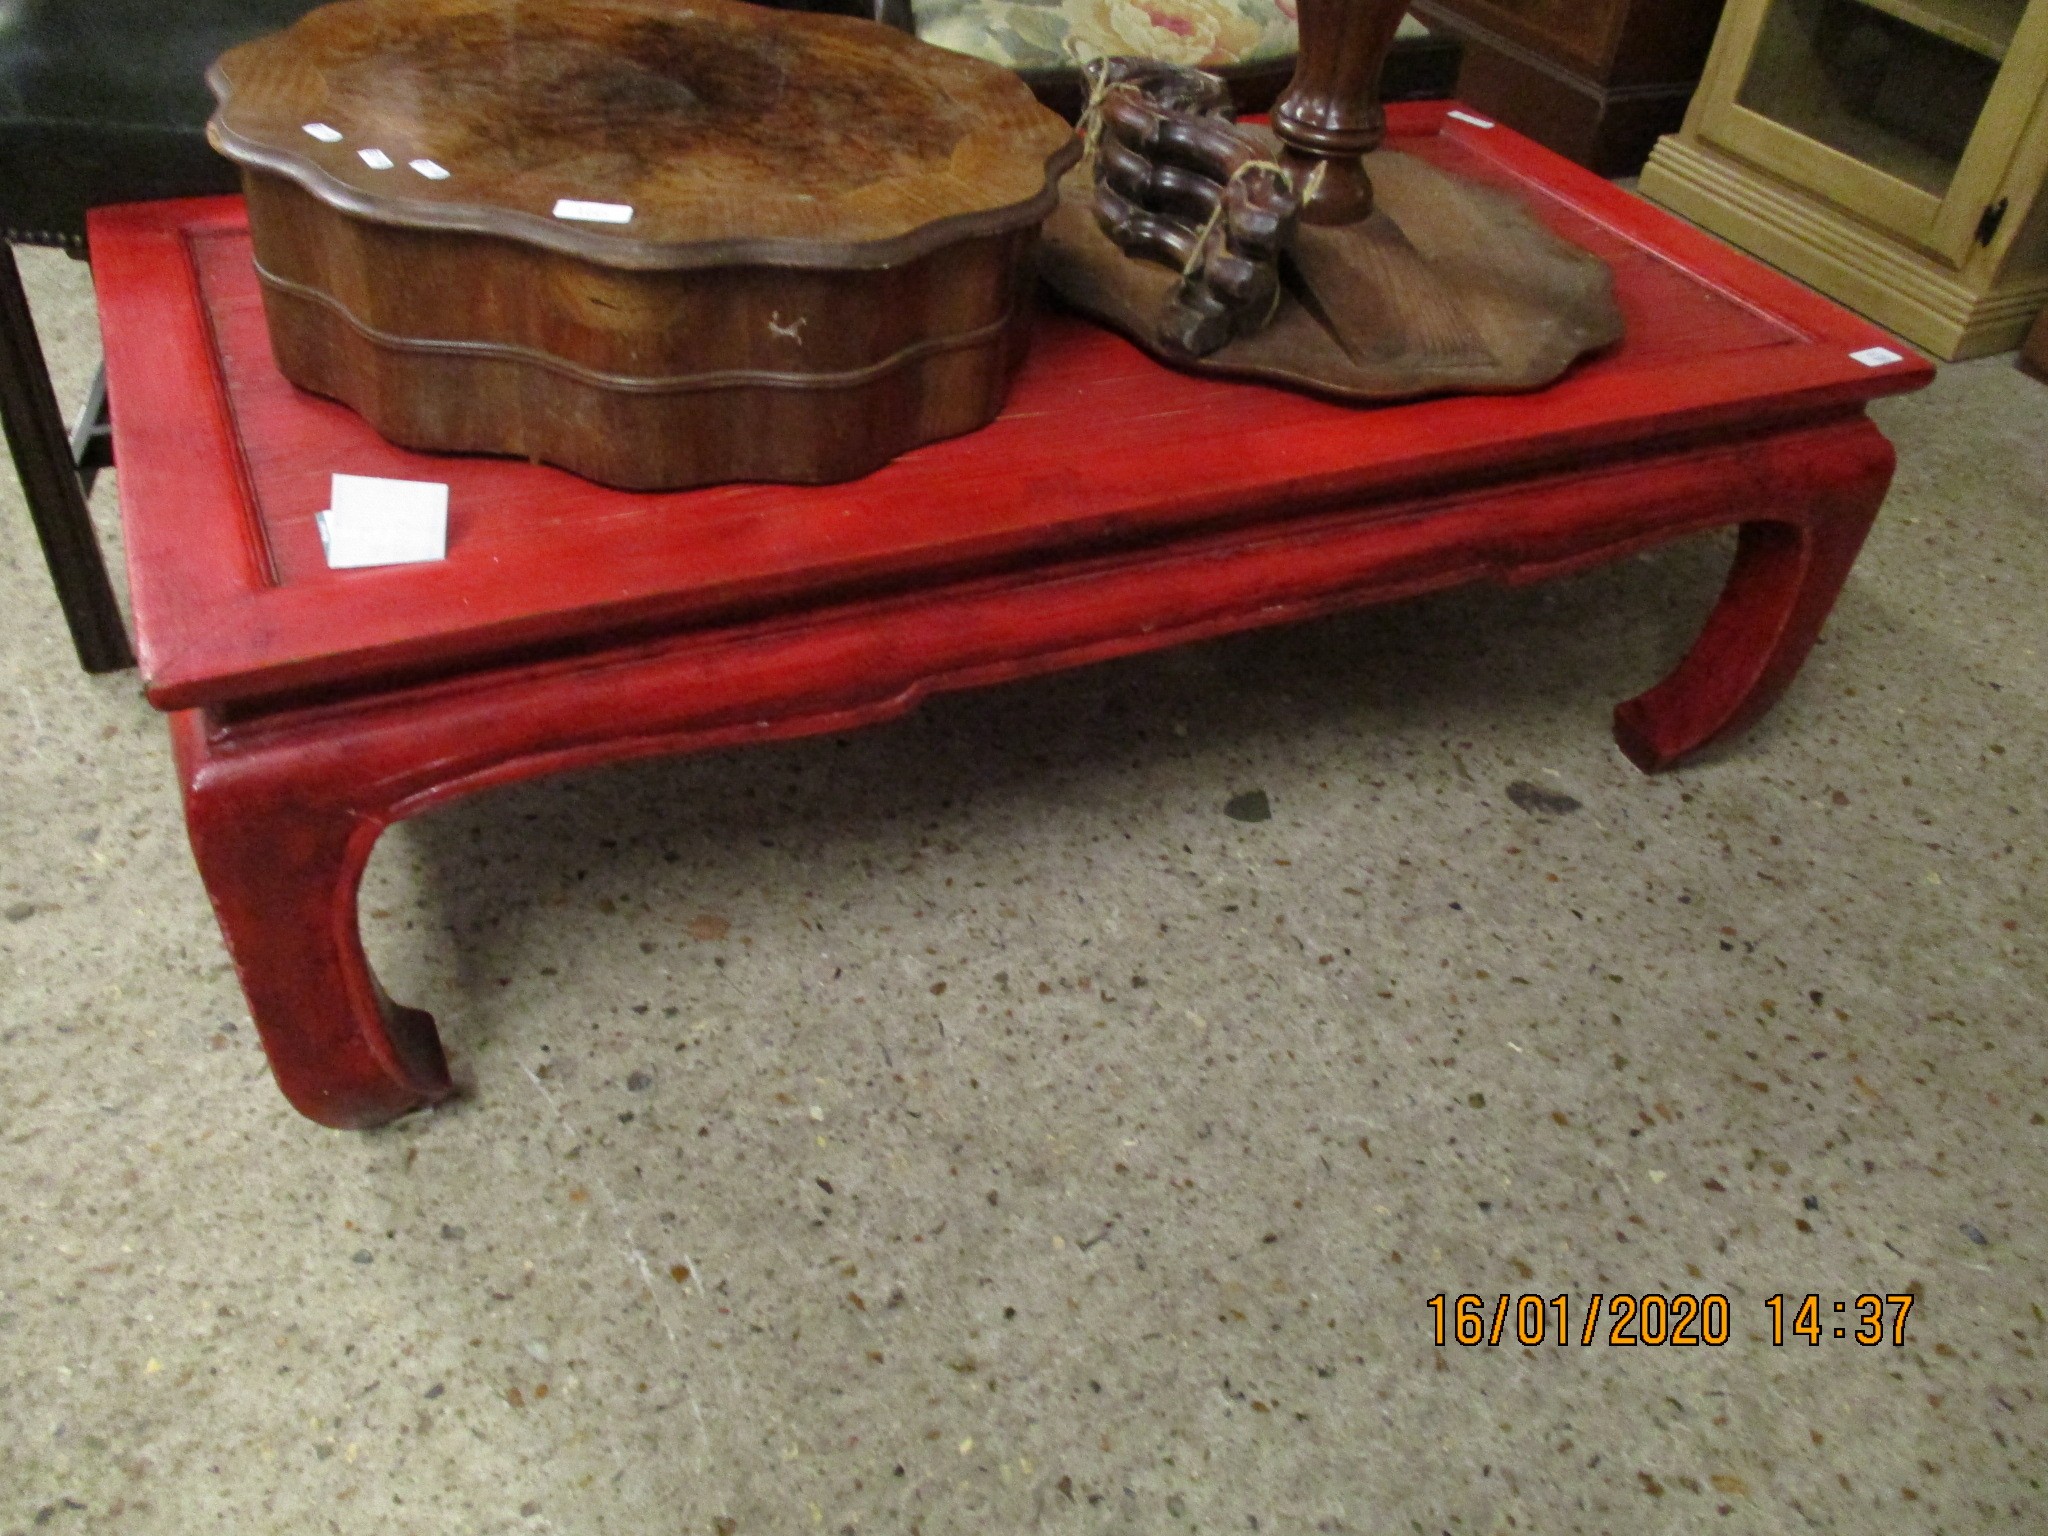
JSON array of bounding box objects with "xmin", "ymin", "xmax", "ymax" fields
[{"xmin": 92, "ymin": 104, "xmax": 1931, "ymax": 1126}]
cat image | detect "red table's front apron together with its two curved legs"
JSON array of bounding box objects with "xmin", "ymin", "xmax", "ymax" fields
[{"xmin": 155, "ymin": 418, "xmax": 1892, "ymax": 1126}]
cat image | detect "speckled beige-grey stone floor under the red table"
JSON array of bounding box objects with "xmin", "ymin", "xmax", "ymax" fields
[{"xmin": 0, "ymin": 252, "xmax": 2048, "ymax": 1536}]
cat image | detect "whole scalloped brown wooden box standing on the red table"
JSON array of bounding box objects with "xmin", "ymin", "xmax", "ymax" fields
[{"xmin": 211, "ymin": 0, "xmax": 1079, "ymax": 489}]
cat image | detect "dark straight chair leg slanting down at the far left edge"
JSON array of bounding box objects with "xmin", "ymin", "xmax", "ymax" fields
[{"xmin": 0, "ymin": 242, "xmax": 135, "ymax": 672}]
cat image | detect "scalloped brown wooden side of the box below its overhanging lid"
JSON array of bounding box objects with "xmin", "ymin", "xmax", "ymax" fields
[{"xmin": 244, "ymin": 172, "xmax": 1036, "ymax": 492}]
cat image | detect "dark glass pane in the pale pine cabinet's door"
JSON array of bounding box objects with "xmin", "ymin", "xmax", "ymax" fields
[{"xmin": 1737, "ymin": 0, "xmax": 2028, "ymax": 197}]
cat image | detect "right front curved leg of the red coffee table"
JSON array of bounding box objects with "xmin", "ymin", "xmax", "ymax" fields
[{"xmin": 1614, "ymin": 422, "xmax": 1892, "ymax": 772}]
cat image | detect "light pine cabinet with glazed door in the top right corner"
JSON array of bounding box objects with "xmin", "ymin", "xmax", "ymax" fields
[{"xmin": 1642, "ymin": 0, "xmax": 2048, "ymax": 358}]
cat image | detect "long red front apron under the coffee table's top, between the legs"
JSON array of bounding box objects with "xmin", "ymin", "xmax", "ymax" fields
[{"xmin": 174, "ymin": 414, "xmax": 1892, "ymax": 825}]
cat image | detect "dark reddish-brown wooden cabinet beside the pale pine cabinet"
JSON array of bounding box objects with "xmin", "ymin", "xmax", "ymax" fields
[{"xmin": 1411, "ymin": 0, "xmax": 1722, "ymax": 176}]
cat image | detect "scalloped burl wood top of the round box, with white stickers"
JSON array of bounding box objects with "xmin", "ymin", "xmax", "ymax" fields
[{"xmin": 209, "ymin": 0, "xmax": 1069, "ymax": 268}]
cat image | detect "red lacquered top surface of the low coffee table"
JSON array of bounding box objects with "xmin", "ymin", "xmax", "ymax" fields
[{"xmin": 92, "ymin": 104, "xmax": 1931, "ymax": 709}]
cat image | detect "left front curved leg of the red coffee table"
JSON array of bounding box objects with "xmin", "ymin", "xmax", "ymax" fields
[{"xmin": 172, "ymin": 711, "xmax": 455, "ymax": 1128}]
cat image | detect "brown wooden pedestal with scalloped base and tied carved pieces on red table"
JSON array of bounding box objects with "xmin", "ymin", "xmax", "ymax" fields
[{"xmin": 1042, "ymin": 0, "xmax": 1622, "ymax": 399}]
